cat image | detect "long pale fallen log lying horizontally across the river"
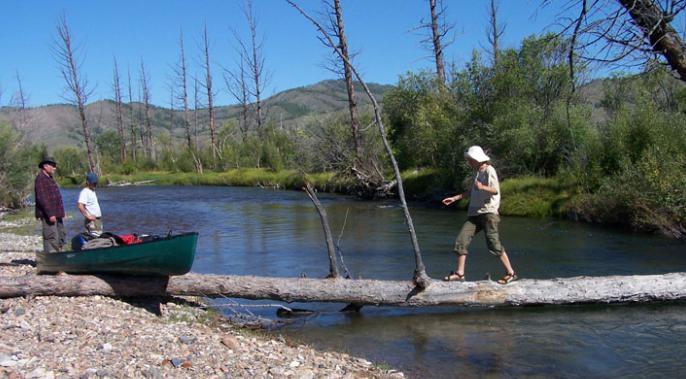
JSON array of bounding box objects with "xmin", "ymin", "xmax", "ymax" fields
[{"xmin": 0, "ymin": 273, "xmax": 686, "ymax": 307}]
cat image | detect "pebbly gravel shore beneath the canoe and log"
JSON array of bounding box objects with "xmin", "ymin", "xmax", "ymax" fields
[{"xmin": 0, "ymin": 232, "xmax": 404, "ymax": 378}]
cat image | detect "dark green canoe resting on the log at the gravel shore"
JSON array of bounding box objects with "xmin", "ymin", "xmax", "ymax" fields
[{"xmin": 36, "ymin": 232, "xmax": 198, "ymax": 276}]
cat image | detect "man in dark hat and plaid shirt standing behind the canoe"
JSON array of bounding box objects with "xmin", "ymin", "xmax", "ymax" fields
[{"xmin": 34, "ymin": 158, "xmax": 65, "ymax": 253}]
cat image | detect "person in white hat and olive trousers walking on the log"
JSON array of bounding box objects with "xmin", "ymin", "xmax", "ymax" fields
[{"xmin": 443, "ymin": 146, "xmax": 517, "ymax": 284}]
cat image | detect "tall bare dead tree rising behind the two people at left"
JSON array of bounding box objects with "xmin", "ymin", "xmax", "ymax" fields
[{"xmin": 53, "ymin": 15, "xmax": 97, "ymax": 171}]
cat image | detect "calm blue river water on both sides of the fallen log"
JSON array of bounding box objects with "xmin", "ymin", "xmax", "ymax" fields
[{"xmin": 63, "ymin": 187, "xmax": 686, "ymax": 378}]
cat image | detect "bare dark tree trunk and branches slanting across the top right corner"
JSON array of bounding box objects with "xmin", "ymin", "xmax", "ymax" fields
[{"xmin": 543, "ymin": 0, "xmax": 686, "ymax": 81}]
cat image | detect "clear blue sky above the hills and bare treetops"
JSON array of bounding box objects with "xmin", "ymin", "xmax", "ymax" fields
[{"xmin": 0, "ymin": 0, "xmax": 566, "ymax": 107}]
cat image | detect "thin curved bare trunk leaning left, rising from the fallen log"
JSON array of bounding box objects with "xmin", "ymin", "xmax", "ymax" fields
[{"xmin": 286, "ymin": 0, "xmax": 431, "ymax": 289}]
